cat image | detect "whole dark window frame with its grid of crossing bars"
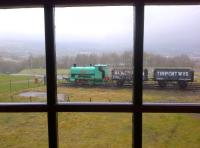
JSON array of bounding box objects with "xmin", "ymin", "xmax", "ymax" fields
[{"xmin": 0, "ymin": 0, "xmax": 200, "ymax": 148}]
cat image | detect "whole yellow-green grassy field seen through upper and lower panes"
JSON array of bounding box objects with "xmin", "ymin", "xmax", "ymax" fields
[{"xmin": 0, "ymin": 75, "xmax": 200, "ymax": 148}]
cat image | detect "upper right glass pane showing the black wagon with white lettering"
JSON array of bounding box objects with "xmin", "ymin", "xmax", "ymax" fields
[{"xmin": 144, "ymin": 5, "xmax": 200, "ymax": 103}]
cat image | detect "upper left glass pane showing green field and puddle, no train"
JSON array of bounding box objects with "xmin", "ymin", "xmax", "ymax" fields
[{"xmin": 0, "ymin": 8, "xmax": 46, "ymax": 102}]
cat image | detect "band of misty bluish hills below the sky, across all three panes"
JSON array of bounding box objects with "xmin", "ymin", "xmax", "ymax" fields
[{"xmin": 0, "ymin": 39, "xmax": 200, "ymax": 59}]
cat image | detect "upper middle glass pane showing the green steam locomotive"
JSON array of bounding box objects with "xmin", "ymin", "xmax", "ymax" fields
[{"xmin": 55, "ymin": 6, "xmax": 134, "ymax": 102}]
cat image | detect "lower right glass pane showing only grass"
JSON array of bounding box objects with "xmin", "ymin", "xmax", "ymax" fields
[{"xmin": 143, "ymin": 113, "xmax": 200, "ymax": 148}]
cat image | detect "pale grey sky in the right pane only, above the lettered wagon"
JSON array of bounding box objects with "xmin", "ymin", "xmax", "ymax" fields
[{"xmin": 145, "ymin": 6, "xmax": 200, "ymax": 53}]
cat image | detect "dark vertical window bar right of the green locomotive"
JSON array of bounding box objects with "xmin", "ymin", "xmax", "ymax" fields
[{"xmin": 133, "ymin": 0, "xmax": 144, "ymax": 148}]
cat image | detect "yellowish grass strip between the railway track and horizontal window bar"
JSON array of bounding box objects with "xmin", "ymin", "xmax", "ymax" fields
[{"xmin": 58, "ymin": 87, "xmax": 200, "ymax": 103}]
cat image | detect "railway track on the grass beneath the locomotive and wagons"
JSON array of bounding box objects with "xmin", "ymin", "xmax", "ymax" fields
[{"xmin": 57, "ymin": 82, "xmax": 200, "ymax": 91}]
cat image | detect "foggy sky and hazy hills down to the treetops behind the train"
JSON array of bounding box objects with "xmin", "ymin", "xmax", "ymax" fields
[{"xmin": 0, "ymin": 6, "xmax": 200, "ymax": 71}]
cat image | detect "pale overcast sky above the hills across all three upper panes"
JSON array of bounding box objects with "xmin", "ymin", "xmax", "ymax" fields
[{"xmin": 0, "ymin": 6, "xmax": 200, "ymax": 54}]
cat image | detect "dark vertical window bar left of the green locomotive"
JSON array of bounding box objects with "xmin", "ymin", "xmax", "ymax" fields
[{"xmin": 44, "ymin": 4, "xmax": 58, "ymax": 148}]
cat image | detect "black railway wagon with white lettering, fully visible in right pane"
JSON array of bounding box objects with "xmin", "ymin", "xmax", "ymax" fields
[{"xmin": 154, "ymin": 68, "xmax": 194, "ymax": 88}]
